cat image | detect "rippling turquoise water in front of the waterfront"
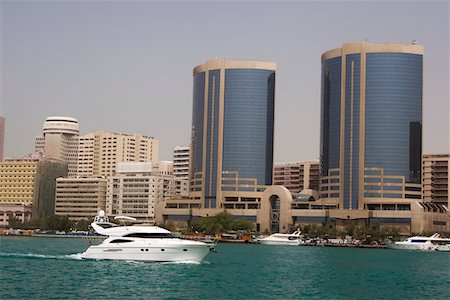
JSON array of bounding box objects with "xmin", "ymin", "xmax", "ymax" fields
[{"xmin": 0, "ymin": 237, "xmax": 450, "ymax": 299}]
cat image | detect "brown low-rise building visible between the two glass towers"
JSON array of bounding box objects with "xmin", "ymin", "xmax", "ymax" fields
[{"xmin": 273, "ymin": 161, "xmax": 320, "ymax": 193}]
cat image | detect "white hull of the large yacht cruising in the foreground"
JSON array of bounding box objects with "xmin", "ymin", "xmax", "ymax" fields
[{"xmin": 81, "ymin": 239, "xmax": 215, "ymax": 262}]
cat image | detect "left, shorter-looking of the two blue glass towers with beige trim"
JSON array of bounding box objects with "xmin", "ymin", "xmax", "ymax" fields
[{"xmin": 190, "ymin": 59, "xmax": 276, "ymax": 208}]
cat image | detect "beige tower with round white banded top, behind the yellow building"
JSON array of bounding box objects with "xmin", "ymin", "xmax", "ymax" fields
[{"xmin": 35, "ymin": 116, "xmax": 80, "ymax": 177}]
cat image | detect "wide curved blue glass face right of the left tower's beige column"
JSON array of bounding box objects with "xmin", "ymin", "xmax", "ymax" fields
[{"xmin": 222, "ymin": 69, "xmax": 275, "ymax": 185}]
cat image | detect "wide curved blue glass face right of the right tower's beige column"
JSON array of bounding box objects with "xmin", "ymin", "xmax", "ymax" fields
[{"xmin": 364, "ymin": 53, "xmax": 422, "ymax": 183}]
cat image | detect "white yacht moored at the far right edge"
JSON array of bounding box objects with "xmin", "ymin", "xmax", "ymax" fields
[{"xmin": 386, "ymin": 233, "xmax": 450, "ymax": 252}]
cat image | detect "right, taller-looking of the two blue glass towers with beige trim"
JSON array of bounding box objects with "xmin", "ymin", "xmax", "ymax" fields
[{"xmin": 320, "ymin": 42, "xmax": 424, "ymax": 210}]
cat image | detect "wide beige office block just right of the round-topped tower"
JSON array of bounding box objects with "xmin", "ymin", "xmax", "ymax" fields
[{"xmin": 77, "ymin": 132, "xmax": 159, "ymax": 177}]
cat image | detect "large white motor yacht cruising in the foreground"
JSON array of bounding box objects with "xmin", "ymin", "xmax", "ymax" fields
[{"xmin": 81, "ymin": 211, "xmax": 216, "ymax": 262}]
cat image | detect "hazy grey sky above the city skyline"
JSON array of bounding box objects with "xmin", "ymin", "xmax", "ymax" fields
[{"xmin": 0, "ymin": 0, "xmax": 450, "ymax": 162}]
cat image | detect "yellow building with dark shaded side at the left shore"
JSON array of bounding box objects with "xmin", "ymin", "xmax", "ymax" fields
[{"xmin": 0, "ymin": 155, "xmax": 67, "ymax": 220}]
